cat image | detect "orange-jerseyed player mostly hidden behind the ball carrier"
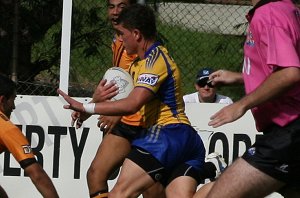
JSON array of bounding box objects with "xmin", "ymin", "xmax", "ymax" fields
[{"xmin": 72, "ymin": 0, "xmax": 165, "ymax": 198}]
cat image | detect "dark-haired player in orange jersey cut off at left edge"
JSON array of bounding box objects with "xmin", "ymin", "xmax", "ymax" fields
[{"xmin": 0, "ymin": 75, "xmax": 58, "ymax": 198}]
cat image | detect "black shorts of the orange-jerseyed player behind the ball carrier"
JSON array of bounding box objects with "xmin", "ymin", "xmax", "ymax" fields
[{"xmin": 111, "ymin": 122, "xmax": 143, "ymax": 142}]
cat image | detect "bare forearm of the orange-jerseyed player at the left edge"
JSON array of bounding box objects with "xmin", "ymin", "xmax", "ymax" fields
[{"xmin": 24, "ymin": 163, "xmax": 59, "ymax": 198}]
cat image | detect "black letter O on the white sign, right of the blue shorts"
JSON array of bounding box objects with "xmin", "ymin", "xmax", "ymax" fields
[{"xmin": 208, "ymin": 132, "xmax": 229, "ymax": 164}]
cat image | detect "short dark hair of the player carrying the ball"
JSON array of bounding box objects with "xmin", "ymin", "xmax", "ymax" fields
[{"xmin": 118, "ymin": 4, "xmax": 157, "ymax": 39}]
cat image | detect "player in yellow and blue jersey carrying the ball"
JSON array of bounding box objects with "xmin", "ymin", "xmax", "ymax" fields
[{"xmin": 58, "ymin": 4, "xmax": 205, "ymax": 198}]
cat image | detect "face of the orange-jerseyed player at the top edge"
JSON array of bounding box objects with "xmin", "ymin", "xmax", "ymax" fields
[{"xmin": 108, "ymin": 0, "xmax": 129, "ymax": 27}]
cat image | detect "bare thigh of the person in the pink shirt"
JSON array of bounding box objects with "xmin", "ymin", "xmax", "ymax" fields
[{"xmin": 207, "ymin": 158, "xmax": 284, "ymax": 198}]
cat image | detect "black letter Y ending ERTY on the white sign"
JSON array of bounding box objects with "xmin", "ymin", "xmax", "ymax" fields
[{"xmin": 69, "ymin": 127, "xmax": 89, "ymax": 179}]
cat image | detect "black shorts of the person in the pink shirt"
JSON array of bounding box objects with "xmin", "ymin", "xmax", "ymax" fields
[{"xmin": 242, "ymin": 119, "xmax": 300, "ymax": 190}]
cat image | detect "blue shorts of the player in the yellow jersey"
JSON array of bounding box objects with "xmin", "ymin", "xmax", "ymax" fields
[{"xmin": 132, "ymin": 124, "xmax": 205, "ymax": 170}]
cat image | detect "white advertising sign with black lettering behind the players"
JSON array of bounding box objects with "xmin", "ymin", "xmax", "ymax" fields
[{"xmin": 0, "ymin": 96, "xmax": 279, "ymax": 198}]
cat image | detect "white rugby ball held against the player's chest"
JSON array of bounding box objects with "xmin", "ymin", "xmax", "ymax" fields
[{"xmin": 103, "ymin": 67, "xmax": 134, "ymax": 100}]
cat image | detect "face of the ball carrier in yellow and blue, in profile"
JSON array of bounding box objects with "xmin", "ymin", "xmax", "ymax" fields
[{"xmin": 116, "ymin": 24, "xmax": 138, "ymax": 55}]
